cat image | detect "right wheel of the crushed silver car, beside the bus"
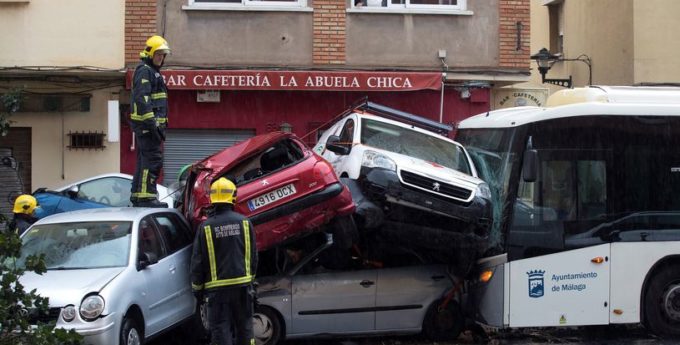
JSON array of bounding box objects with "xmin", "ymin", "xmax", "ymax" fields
[{"xmin": 423, "ymin": 300, "xmax": 465, "ymax": 341}]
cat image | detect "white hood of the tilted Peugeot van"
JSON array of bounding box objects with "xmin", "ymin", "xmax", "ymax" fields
[{"xmin": 370, "ymin": 147, "xmax": 484, "ymax": 189}]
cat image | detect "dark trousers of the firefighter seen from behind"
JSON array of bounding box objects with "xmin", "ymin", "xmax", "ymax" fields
[{"xmin": 208, "ymin": 286, "xmax": 255, "ymax": 345}]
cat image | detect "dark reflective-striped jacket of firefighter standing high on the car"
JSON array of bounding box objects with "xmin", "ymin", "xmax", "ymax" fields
[{"xmin": 130, "ymin": 58, "xmax": 168, "ymax": 139}]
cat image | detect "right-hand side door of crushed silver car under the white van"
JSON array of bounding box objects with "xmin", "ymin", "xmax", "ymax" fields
[{"xmin": 375, "ymin": 265, "xmax": 452, "ymax": 331}]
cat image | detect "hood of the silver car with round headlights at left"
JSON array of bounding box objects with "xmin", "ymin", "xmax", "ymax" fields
[{"xmin": 20, "ymin": 267, "xmax": 125, "ymax": 307}]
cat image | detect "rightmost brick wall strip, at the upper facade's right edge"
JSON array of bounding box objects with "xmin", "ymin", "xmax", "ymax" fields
[{"xmin": 498, "ymin": 0, "xmax": 531, "ymax": 68}]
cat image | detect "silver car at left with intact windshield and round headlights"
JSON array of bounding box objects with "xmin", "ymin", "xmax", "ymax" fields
[{"xmin": 19, "ymin": 207, "xmax": 195, "ymax": 345}]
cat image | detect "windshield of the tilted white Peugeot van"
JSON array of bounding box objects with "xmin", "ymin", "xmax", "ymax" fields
[{"xmin": 361, "ymin": 119, "xmax": 471, "ymax": 175}]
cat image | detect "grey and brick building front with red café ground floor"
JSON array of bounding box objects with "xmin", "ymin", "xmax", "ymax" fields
[{"xmin": 126, "ymin": 0, "xmax": 530, "ymax": 183}]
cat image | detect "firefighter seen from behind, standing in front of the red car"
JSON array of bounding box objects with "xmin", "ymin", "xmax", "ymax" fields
[{"xmin": 191, "ymin": 177, "xmax": 257, "ymax": 345}]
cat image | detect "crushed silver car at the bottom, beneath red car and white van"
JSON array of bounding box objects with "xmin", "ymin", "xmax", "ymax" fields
[{"xmin": 253, "ymin": 234, "xmax": 464, "ymax": 345}]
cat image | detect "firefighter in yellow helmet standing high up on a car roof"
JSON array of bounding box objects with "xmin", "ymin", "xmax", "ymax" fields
[{"xmin": 130, "ymin": 36, "xmax": 170, "ymax": 207}]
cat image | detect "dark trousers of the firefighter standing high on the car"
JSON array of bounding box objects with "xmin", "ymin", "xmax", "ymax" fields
[{"xmin": 130, "ymin": 131, "xmax": 163, "ymax": 204}]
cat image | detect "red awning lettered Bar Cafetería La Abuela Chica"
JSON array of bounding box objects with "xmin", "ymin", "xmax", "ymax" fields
[{"xmin": 126, "ymin": 70, "xmax": 442, "ymax": 91}]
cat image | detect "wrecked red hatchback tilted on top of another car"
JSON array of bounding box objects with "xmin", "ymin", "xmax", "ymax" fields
[{"xmin": 179, "ymin": 132, "xmax": 356, "ymax": 251}]
